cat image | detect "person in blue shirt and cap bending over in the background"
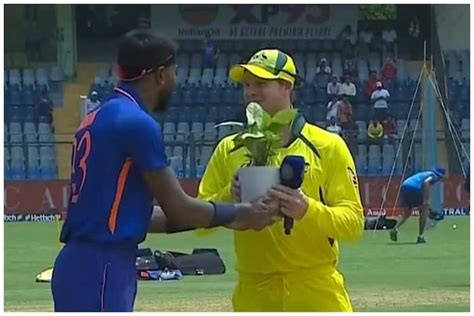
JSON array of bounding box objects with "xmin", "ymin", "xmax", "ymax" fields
[{"xmin": 390, "ymin": 166, "xmax": 446, "ymax": 244}]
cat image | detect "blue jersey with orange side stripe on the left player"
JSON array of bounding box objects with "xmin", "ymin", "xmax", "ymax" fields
[{"xmin": 61, "ymin": 83, "xmax": 168, "ymax": 244}]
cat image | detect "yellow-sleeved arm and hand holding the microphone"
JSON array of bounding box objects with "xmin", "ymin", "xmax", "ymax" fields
[{"xmin": 271, "ymin": 138, "xmax": 364, "ymax": 241}]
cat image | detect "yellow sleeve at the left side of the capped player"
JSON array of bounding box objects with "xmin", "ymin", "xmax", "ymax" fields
[{"xmin": 198, "ymin": 140, "xmax": 232, "ymax": 202}]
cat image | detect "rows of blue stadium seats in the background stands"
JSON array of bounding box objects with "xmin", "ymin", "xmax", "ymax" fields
[{"xmin": 4, "ymin": 40, "xmax": 470, "ymax": 178}]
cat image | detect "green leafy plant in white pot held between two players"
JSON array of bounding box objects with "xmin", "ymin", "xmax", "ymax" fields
[{"xmin": 216, "ymin": 102, "xmax": 298, "ymax": 202}]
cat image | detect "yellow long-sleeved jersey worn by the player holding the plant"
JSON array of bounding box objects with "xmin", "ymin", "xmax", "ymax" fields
[{"xmin": 198, "ymin": 116, "xmax": 364, "ymax": 274}]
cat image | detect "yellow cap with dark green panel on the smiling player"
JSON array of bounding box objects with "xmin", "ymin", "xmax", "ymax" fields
[{"xmin": 229, "ymin": 49, "xmax": 298, "ymax": 85}]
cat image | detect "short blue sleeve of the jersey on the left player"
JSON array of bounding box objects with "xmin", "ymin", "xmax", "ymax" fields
[{"xmin": 123, "ymin": 117, "xmax": 168, "ymax": 171}]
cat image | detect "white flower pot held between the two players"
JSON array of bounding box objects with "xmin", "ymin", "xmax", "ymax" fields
[{"xmin": 237, "ymin": 166, "xmax": 280, "ymax": 202}]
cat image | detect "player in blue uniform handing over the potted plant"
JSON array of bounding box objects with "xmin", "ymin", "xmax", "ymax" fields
[{"xmin": 51, "ymin": 30, "xmax": 278, "ymax": 312}]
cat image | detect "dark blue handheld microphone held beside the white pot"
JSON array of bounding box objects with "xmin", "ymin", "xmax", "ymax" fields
[{"xmin": 280, "ymin": 156, "xmax": 305, "ymax": 235}]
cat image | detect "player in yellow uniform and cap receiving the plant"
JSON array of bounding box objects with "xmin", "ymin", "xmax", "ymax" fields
[{"xmin": 199, "ymin": 49, "xmax": 364, "ymax": 312}]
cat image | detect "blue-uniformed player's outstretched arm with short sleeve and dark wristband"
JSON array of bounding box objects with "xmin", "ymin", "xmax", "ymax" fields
[{"xmin": 119, "ymin": 117, "xmax": 276, "ymax": 232}]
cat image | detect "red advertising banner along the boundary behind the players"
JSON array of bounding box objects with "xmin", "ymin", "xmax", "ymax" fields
[{"xmin": 4, "ymin": 176, "xmax": 469, "ymax": 214}]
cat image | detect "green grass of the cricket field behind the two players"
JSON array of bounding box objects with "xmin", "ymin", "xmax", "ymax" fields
[{"xmin": 4, "ymin": 217, "xmax": 470, "ymax": 312}]
